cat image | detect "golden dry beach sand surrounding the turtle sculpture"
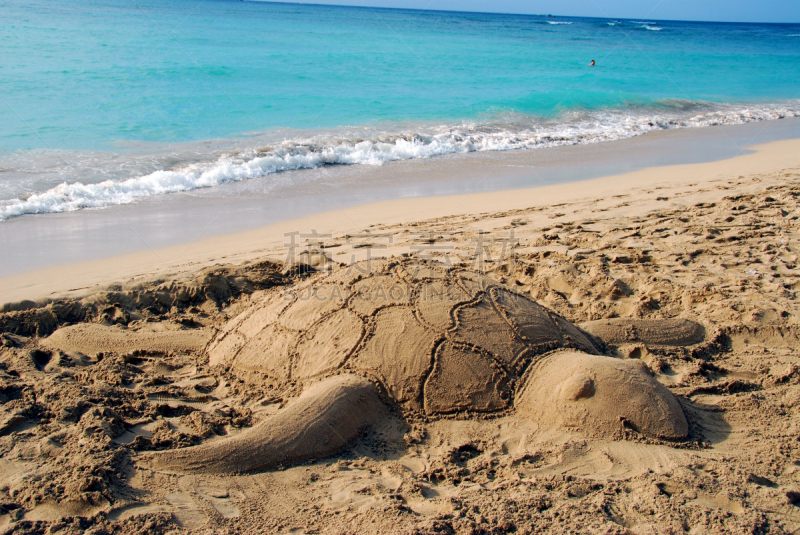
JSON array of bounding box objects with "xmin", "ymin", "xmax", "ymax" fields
[{"xmin": 0, "ymin": 136, "xmax": 800, "ymax": 534}]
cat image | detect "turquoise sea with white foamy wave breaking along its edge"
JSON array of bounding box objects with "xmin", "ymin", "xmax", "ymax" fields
[{"xmin": 0, "ymin": 0, "xmax": 800, "ymax": 220}]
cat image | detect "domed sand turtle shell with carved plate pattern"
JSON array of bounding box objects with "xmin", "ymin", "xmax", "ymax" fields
[{"xmin": 208, "ymin": 262, "xmax": 598, "ymax": 415}]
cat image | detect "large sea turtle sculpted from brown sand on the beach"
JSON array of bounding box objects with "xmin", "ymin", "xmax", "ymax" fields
[{"xmin": 150, "ymin": 262, "xmax": 700, "ymax": 473}]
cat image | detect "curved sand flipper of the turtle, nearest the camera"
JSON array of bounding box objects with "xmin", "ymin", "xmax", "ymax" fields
[{"xmin": 147, "ymin": 374, "xmax": 387, "ymax": 474}]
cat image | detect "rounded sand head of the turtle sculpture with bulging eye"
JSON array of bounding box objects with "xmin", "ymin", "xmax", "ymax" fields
[{"xmin": 515, "ymin": 352, "xmax": 689, "ymax": 440}]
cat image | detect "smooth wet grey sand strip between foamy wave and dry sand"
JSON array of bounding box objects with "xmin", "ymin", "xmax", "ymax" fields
[{"xmin": 0, "ymin": 118, "xmax": 800, "ymax": 278}]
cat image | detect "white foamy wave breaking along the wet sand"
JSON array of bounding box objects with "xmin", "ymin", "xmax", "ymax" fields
[{"xmin": 0, "ymin": 100, "xmax": 800, "ymax": 221}]
